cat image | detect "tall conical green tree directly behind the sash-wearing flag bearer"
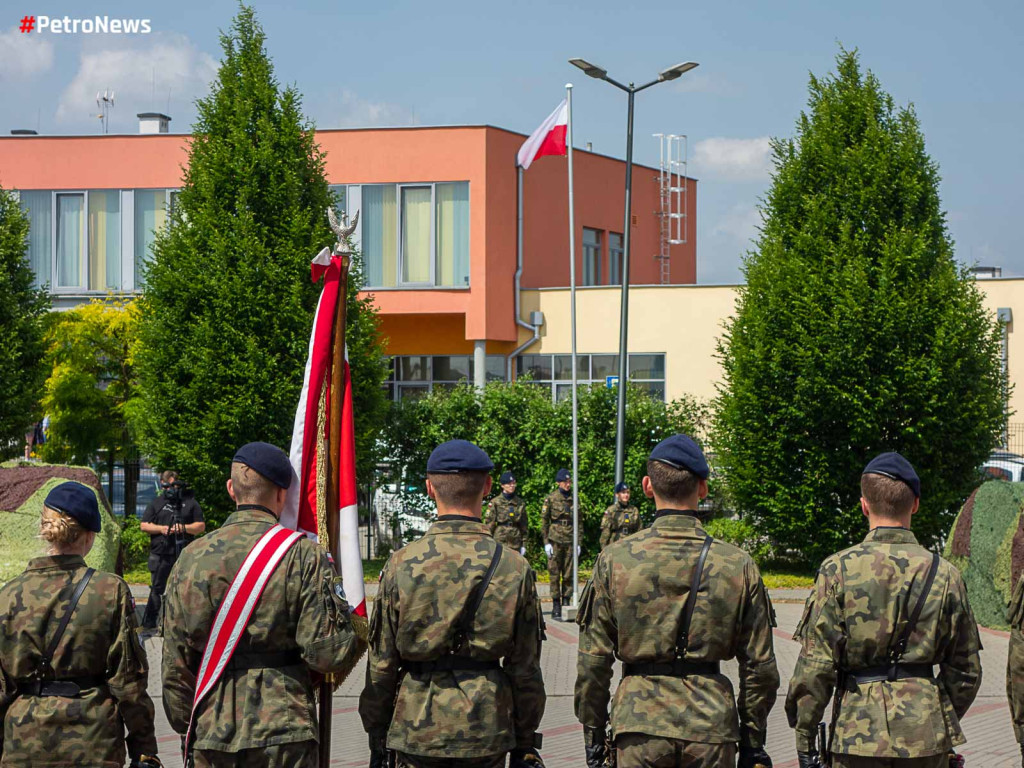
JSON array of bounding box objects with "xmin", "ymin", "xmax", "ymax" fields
[{"xmin": 135, "ymin": 6, "xmax": 386, "ymax": 521}]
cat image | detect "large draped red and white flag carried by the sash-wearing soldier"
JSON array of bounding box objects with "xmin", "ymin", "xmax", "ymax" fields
[{"xmin": 281, "ymin": 248, "xmax": 367, "ymax": 616}]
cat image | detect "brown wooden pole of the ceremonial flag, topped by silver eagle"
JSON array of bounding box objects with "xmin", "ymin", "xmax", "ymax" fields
[{"xmin": 317, "ymin": 253, "xmax": 349, "ymax": 768}]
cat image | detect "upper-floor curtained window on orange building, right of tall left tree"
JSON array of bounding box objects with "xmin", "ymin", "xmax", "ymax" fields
[{"xmin": 360, "ymin": 181, "xmax": 469, "ymax": 288}]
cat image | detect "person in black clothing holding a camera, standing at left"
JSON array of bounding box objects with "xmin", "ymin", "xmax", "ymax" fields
[{"xmin": 139, "ymin": 469, "xmax": 206, "ymax": 631}]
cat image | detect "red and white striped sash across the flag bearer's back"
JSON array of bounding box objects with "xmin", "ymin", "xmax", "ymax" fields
[{"xmin": 182, "ymin": 525, "xmax": 303, "ymax": 761}]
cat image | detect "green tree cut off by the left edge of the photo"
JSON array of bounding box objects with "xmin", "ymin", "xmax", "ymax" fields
[{"xmin": 0, "ymin": 187, "xmax": 50, "ymax": 459}]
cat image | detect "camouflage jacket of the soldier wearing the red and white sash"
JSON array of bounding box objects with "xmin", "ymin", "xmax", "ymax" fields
[{"xmin": 163, "ymin": 510, "xmax": 364, "ymax": 752}]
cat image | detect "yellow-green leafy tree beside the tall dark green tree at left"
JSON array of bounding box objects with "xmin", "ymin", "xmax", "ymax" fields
[{"xmin": 42, "ymin": 300, "xmax": 138, "ymax": 465}]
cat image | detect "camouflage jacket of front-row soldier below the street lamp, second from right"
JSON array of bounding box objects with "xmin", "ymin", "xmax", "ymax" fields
[{"xmin": 575, "ymin": 511, "xmax": 779, "ymax": 746}]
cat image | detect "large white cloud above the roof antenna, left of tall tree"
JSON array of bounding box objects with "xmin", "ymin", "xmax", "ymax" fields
[{"xmin": 56, "ymin": 34, "xmax": 217, "ymax": 130}]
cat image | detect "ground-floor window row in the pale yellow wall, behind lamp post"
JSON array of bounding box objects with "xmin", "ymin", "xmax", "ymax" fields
[{"xmin": 516, "ymin": 353, "xmax": 665, "ymax": 400}]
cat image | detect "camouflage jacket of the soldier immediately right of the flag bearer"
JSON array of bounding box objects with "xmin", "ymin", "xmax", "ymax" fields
[{"xmin": 359, "ymin": 515, "xmax": 546, "ymax": 758}]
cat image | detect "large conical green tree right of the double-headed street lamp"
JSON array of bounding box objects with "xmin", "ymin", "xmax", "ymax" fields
[{"xmin": 717, "ymin": 50, "xmax": 1007, "ymax": 560}]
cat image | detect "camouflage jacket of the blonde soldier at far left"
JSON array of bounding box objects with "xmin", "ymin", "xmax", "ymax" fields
[{"xmin": 0, "ymin": 555, "xmax": 157, "ymax": 768}]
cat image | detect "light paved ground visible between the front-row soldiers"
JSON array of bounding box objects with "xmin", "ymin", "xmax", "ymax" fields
[{"xmin": 137, "ymin": 590, "xmax": 1020, "ymax": 768}]
